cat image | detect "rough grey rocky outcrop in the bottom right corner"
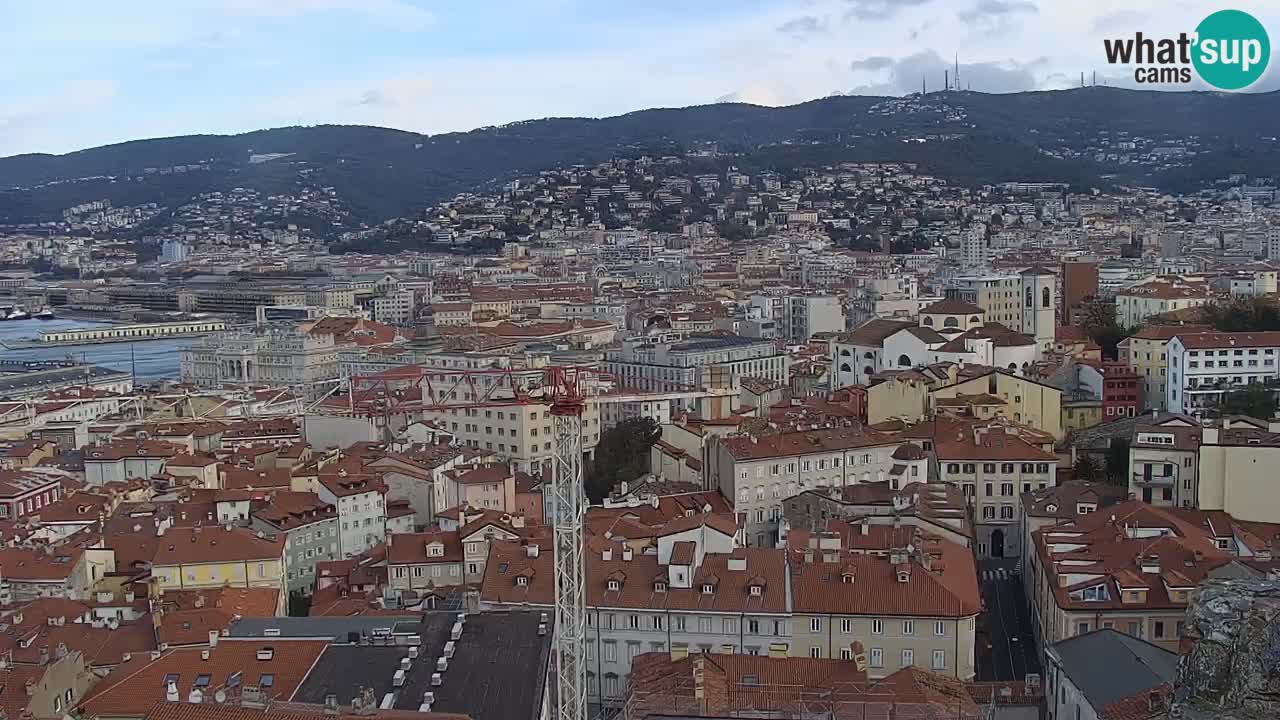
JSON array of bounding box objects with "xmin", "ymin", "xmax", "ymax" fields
[{"xmin": 1169, "ymin": 579, "xmax": 1280, "ymax": 719}]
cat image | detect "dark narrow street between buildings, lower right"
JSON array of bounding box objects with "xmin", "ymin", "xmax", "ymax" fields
[{"xmin": 977, "ymin": 560, "xmax": 1041, "ymax": 680}]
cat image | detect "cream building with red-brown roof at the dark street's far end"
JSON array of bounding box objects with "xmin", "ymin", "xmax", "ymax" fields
[{"xmin": 926, "ymin": 416, "xmax": 1057, "ymax": 557}]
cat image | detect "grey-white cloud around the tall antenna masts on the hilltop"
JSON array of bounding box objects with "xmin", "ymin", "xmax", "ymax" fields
[{"xmin": 849, "ymin": 50, "xmax": 1042, "ymax": 95}]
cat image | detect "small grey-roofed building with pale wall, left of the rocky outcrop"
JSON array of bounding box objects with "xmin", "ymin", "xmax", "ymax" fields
[{"xmin": 1044, "ymin": 629, "xmax": 1178, "ymax": 720}]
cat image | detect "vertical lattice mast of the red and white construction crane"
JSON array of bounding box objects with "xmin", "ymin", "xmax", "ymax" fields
[{"xmin": 550, "ymin": 368, "xmax": 586, "ymax": 720}]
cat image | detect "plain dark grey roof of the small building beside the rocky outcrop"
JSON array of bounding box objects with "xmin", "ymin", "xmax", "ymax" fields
[{"xmin": 1050, "ymin": 629, "xmax": 1178, "ymax": 712}]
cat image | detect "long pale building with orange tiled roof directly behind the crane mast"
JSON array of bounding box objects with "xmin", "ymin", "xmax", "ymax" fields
[{"xmin": 480, "ymin": 524, "xmax": 791, "ymax": 705}]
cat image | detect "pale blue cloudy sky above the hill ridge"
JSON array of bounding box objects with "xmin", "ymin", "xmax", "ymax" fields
[{"xmin": 0, "ymin": 0, "xmax": 1280, "ymax": 156}]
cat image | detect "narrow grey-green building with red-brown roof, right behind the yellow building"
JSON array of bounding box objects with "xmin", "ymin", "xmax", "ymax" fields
[{"xmin": 250, "ymin": 491, "xmax": 339, "ymax": 594}]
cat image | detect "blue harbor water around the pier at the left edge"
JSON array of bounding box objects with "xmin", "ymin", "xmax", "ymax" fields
[{"xmin": 0, "ymin": 319, "xmax": 185, "ymax": 382}]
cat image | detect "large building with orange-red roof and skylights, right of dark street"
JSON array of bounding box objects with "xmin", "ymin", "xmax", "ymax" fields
[{"xmin": 1023, "ymin": 501, "xmax": 1280, "ymax": 652}]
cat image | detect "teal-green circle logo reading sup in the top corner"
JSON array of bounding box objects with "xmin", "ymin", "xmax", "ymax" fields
[{"xmin": 1192, "ymin": 10, "xmax": 1271, "ymax": 90}]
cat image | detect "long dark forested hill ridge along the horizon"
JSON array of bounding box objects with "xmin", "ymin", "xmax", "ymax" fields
[{"xmin": 0, "ymin": 87, "xmax": 1280, "ymax": 223}]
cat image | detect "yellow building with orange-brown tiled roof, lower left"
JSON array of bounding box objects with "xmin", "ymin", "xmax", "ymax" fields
[{"xmin": 151, "ymin": 525, "xmax": 287, "ymax": 611}]
